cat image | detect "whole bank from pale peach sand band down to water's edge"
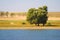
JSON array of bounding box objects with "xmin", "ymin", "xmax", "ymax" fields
[{"xmin": 0, "ymin": 13, "xmax": 60, "ymax": 30}]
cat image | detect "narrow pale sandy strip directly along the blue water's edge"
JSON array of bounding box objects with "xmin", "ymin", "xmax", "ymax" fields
[{"xmin": 0, "ymin": 27, "xmax": 60, "ymax": 30}]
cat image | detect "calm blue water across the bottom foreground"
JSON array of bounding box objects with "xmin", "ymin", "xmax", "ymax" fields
[{"xmin": 0, "ymin": 30, "xmax": 60, "ymax": 40}]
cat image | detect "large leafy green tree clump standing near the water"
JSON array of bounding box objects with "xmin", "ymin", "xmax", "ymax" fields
[{"xmin": 27, "ymin": 6, "xmax": 48, "ymax": 26}]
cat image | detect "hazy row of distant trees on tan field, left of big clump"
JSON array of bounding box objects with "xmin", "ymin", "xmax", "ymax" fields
[{"xmin": 0, "ymin": 11, "xmax": 27, "ymax": 17}]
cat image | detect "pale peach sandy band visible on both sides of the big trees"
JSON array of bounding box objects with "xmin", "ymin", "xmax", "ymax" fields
[{"xmin": 0, "ymin": 16, "xmax": 60, "ymax": 20}]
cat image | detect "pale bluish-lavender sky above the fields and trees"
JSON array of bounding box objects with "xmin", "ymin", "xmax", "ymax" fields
[{"xmin": 0, "ymin": 0, "xmax": 60, "ymax": 12}]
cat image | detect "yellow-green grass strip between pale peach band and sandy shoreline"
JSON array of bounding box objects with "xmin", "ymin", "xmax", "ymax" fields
[{"xmin": 0, "ymin": 20, "xmax": 60, "ymax": 27}]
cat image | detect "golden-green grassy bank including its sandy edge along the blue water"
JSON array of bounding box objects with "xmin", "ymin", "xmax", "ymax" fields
[{"xmin": 0, "ymin": 20, "xmax": 60, "ymax": 30}]
